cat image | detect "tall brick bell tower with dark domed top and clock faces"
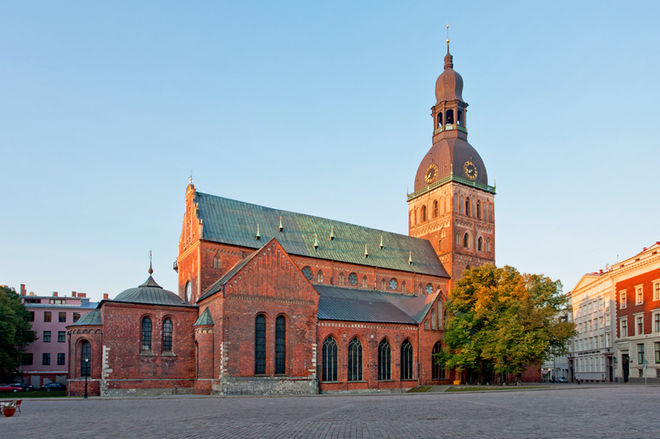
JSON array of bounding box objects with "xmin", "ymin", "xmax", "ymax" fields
[{"xmin": 408, "ymin": 40, "xmax": 495, "ymax": 286}]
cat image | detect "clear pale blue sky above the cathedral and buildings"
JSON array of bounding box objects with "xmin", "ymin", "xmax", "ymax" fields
[{"xmin": 0, "ymin": 1, "xmax": 660, "ymax": 299}]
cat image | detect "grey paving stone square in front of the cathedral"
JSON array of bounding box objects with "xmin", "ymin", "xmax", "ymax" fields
[{"xmin": 0, "ymin": 384, "xmax": 660, "ymax": 439}]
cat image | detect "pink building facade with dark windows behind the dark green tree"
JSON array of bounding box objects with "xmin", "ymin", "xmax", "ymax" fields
[{"xmin": 19, "ymin": 284, "xmax": 97, "ymax": 388}]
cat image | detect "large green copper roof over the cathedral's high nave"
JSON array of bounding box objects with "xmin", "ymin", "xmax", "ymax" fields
[{"xmin": 196, "ymin": 192, "xmax": 449, "ymax": 278}]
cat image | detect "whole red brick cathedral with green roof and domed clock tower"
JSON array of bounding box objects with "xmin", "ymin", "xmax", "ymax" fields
[{"xmin": 68, "ymin": 49, "xmax": 495, "ymax": 396}]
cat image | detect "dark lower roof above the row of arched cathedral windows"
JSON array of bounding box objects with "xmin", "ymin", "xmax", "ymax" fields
[{"xmin": 314, "ymin": 285, "xmax": 437, "ymax": 325}]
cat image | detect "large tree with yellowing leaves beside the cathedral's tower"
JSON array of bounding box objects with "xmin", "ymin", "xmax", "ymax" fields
[{"xmin": 437, "ymin": 264, "xmax": 576, "ymax": 382}]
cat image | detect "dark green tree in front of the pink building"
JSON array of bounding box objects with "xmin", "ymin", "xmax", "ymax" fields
[{"xmin": 0, "ymin": 286, "xmax": 36, "ymax": 380}]
